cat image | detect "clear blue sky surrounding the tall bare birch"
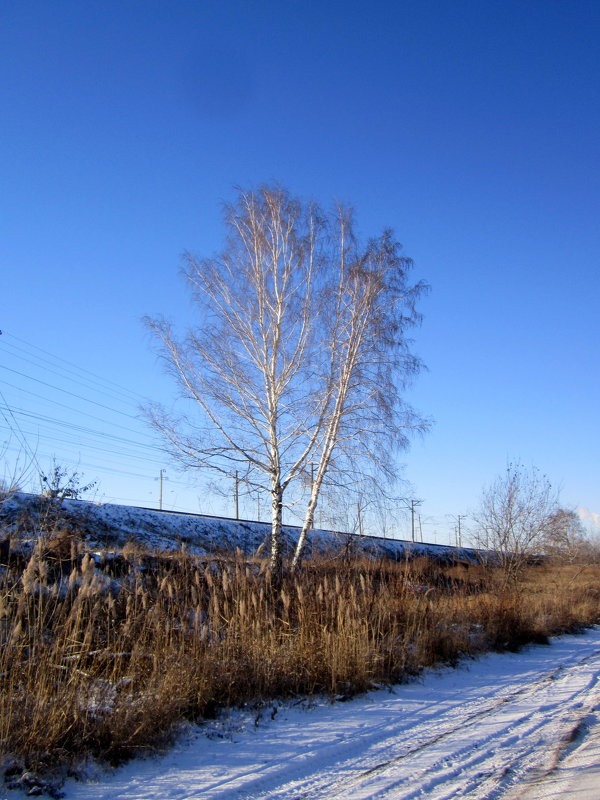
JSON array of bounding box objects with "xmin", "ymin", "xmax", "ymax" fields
[{"xmin": 0, "ymin": 0, "xmax": 600, "ymax": 541}]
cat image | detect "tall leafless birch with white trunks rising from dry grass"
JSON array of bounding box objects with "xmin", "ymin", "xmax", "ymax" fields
[{"xmin": 147, "ymin": 187, "xmax": 425, "ymax": 573}]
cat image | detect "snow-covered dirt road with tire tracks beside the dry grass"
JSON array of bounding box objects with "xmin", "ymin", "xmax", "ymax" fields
[{"xmin": 66, "ymin": 629, "xmax": 600, "ymax": 800}]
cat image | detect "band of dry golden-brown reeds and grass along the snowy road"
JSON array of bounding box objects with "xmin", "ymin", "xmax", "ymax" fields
[{"xmin": 0, "ymin": 531, "xmax": 600, "ymax": 788}]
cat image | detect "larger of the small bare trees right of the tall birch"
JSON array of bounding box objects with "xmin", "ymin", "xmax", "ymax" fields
[{"xmin": 473, "ymin": 463, "xmax": 557, "ymax": 580}]
